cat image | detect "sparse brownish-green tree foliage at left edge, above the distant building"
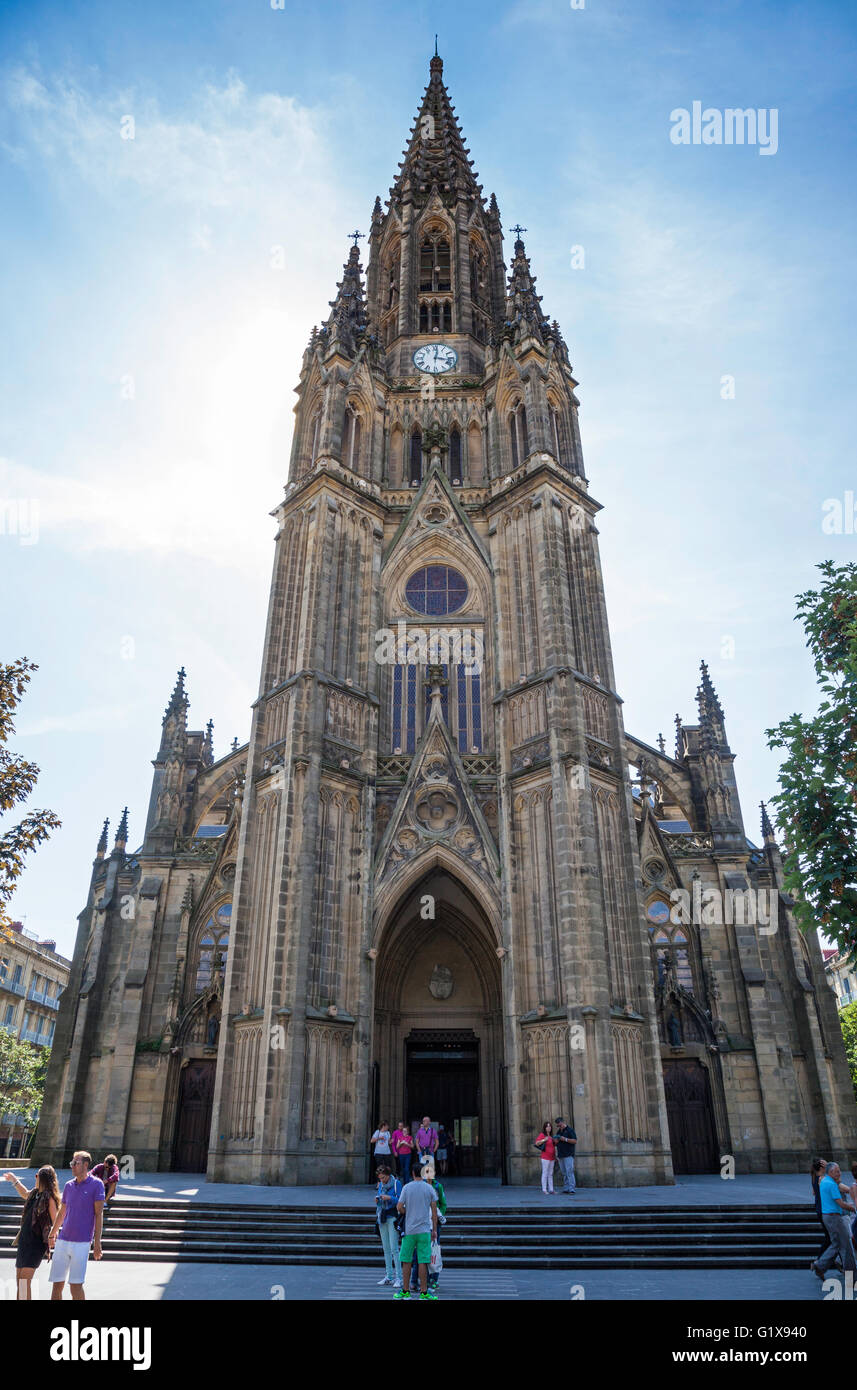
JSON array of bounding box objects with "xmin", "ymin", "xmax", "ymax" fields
[{"xmin": 0, "ymin": 659, "xmax": 61, "ymax": 937}]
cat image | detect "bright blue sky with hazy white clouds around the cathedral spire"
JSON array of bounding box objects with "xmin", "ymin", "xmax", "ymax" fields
[{"xmin": 0, "ymin": 0, "xmax": 857, "ymax": 951}]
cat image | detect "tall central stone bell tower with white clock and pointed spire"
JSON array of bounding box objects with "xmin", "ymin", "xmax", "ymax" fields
[{"xmin": 208, "ymin": 56, "xmax": 672, "ymax": 1183}]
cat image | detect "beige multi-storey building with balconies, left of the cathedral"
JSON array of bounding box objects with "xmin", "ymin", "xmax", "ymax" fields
[{"xmin": 0, "ymin": 922, "xmax": 71, "ymax": 1158}]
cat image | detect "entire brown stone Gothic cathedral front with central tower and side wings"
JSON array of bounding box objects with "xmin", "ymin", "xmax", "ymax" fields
[{"xmin": 36, "ymin": 57, "xmax": 857, "ymax": 1186}]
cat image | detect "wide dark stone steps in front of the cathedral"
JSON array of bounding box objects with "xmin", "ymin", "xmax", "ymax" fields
[{"xmin": 0, "ymin": 1198, "xmax": 819, "ymax": 1269}]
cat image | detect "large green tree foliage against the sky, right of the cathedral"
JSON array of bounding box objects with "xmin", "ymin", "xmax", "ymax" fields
[{"xmin": 767, "ymin": 560, "xmax": 857, "ymax": 952}]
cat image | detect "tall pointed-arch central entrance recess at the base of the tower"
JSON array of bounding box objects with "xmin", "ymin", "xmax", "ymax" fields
[{"xmin": 372, "ymin": 867, "xmax": 506, "ymax": 1176}]
